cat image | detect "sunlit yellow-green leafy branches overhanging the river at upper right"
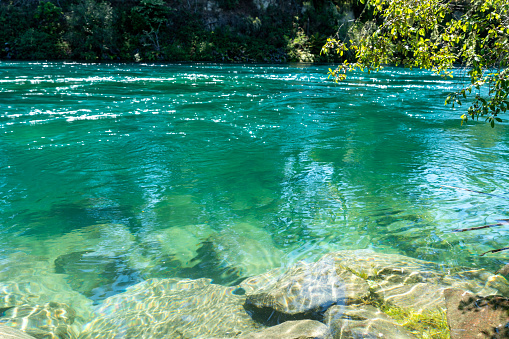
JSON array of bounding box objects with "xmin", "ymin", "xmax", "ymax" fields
[{"xmin": 322, "ymin": 0, "xmax": 509, "ymax": 127}]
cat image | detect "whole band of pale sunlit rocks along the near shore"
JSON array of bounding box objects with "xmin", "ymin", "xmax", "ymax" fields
[{"xmin": 0, "ymin": 250, "xmax": 509, "ymax": 339}]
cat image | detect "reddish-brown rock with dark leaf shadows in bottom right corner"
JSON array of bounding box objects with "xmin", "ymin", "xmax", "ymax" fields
[{"xmin": 445, "ymin": 289, "xmax": 509, "ymax": 339}]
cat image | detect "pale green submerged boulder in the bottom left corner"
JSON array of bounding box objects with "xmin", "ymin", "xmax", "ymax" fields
[{"xmin": 0, "ymin": 253, "xmax": 88, "ymax": 339}]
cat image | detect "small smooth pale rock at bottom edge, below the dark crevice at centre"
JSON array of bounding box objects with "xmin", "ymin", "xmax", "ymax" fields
[{"xmin": 239, "ymin": 320, "xmax": 332, "ymax": 339}]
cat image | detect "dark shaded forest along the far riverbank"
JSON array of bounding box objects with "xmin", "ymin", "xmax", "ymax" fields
[{"xmin": 0, "ymin": 0, "xmax": 362, "ymax": 63}]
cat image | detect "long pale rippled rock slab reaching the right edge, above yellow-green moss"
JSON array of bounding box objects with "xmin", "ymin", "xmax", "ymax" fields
[{"xmin": 324, "ymin": 250, "xmax": 509, "ymax": 309}]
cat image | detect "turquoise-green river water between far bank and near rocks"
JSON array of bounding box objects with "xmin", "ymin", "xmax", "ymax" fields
[{"xmin": 0, "ymin": 62, "xmax": 509, "ymax": 302}]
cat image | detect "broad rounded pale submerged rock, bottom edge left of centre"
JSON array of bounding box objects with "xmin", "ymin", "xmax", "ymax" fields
[{"xmin": 79, "ymin": 279, "xmax": 263, "ymax": 339}]
